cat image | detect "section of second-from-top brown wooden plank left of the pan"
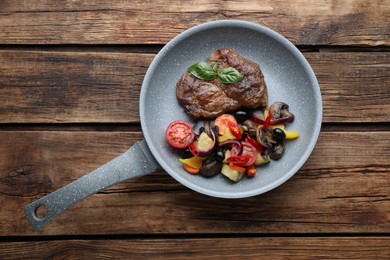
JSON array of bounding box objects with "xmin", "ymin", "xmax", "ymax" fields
[{"xmin": 0, "ymin": 51, "xmax": 154, "ymax": 123}]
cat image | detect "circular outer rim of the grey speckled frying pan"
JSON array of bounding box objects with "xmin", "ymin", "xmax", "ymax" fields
[{"xmin": 139, "ymin": 20, "xmax": 322, "ymax": 199}]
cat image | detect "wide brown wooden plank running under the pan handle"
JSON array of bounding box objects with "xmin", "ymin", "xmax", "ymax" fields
[{"xmin": 0, "ymin": 131, "xmax": 390, "ymax": 236}]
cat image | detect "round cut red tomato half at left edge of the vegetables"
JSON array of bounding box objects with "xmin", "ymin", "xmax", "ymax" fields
[{"xmin": 165, "ymin": 120, "xmax": 195, "ymax": 149}]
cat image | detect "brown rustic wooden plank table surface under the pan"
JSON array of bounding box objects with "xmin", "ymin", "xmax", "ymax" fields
[{"xmin": 0, "ymin": 0, "xmax": 390, "ymax": 259}]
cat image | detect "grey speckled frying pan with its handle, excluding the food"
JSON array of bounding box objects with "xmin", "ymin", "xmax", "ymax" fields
[{"xmin": 25, "ymin": 20, "xmax": 322, "ymax": 229}]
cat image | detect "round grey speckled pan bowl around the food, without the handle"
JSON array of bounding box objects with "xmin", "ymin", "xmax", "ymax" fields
[{"xmin": 140, "ymin": 20, "xmax": 322, "ymax": 198}]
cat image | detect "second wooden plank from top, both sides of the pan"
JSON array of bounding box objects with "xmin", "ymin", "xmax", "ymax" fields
[{"xmin": 0, "ymin": 51, "xmax": 390, "ymax": 123}]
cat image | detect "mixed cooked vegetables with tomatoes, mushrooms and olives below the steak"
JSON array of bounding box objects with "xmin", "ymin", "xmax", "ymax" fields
[{"xmin": 166, "ymin": 102, "xmax": 298, "ymax": 182}]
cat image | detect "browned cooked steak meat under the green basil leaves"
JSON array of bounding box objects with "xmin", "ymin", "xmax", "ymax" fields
[{"xmin": 176, "ymin": 48, "xmax": 268, "ymax": 119}]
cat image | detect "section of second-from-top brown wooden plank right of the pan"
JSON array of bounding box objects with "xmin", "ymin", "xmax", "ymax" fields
[{"xmin": 304, "ymin": 52, "xmax": 390, "ymax": 123}]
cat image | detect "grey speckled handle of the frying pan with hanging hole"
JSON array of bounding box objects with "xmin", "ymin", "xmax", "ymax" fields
[{"xmin": 24, "ymin": 140, "xmax": 160, "ymax": 229}]
